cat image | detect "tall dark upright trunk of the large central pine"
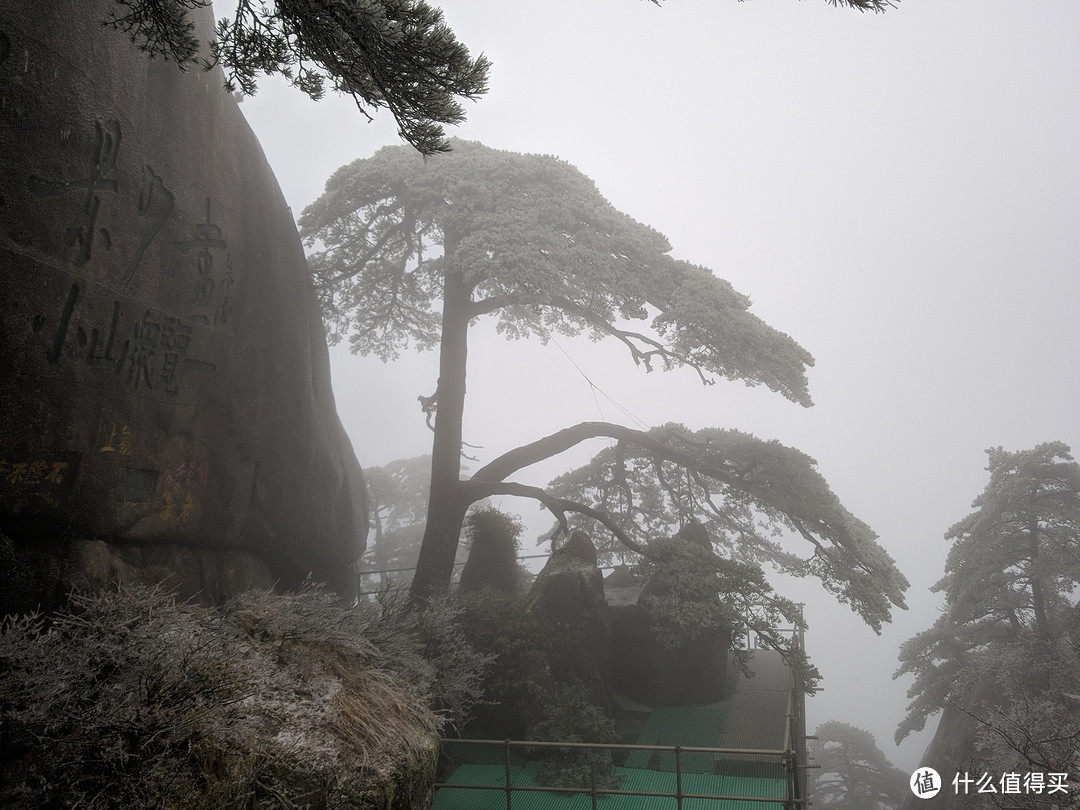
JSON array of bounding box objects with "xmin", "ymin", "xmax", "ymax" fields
[{"xmin": 410, "ymin": 267, "xmax": 471, "ymax": 599}]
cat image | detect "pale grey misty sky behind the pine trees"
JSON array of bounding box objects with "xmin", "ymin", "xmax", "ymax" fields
[{"xmin": 234, "ymin": 0, "xmax": 1080, "ymax": 770}]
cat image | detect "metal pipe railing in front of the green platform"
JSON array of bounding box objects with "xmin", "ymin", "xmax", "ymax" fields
[{"xmin": 435, "ymin": 738, "xmax": 806, "ymax": 810}]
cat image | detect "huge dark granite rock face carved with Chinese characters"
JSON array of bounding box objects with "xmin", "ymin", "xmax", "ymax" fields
[{"xmin": 0, "ymin": 0, "xmax": 367, "ymax": 602}]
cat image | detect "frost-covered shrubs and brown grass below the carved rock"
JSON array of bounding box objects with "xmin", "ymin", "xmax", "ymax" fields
[{"xmin": 0, "ymin": 588, "xmax": 488, "ymax": 809}]
